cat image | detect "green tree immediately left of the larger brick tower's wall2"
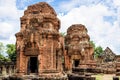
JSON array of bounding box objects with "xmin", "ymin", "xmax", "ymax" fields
[{"xmin": 6, "ymin": 44, "xmax": 16, "ymax": 62}]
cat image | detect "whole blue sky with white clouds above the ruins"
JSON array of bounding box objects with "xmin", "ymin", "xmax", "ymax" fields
[{"xmin": 0, "ymin": 0, "xmax": 120, "ymax": 55}]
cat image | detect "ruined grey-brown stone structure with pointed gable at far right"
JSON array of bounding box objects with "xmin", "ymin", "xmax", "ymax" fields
[{"xmin": 96, "ymin": 47, "xmax": 120, "ymax": 74}]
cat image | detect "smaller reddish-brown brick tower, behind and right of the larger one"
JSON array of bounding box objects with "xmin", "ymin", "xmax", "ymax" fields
[{"xmin": 65, "ymin": 24, "xmax": 94, "ymax": 70}]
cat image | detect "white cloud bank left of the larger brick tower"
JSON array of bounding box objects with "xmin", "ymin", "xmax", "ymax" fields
[{"xmin": 0, "ymin": 0, "xmax": 23, "ymax": 44}]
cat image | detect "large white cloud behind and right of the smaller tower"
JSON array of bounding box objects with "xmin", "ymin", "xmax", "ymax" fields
[{"xmin": 58, "ymin": 3, "xmax": 120, "ymax": 54}]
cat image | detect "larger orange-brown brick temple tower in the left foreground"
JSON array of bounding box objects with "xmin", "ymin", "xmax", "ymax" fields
[{"xmin": 16, "ymin": 2, "xmax": 63, "ymax": 76}]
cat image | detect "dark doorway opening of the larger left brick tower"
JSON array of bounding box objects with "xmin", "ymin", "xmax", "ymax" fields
[{"xmin": 30, "ymin": 57, "xmax": 38, "ymax": 73}]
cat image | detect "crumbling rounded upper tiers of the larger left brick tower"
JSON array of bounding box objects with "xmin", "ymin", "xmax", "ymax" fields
[{"xmin": 20, "ymin": 2, "xmax": 60, "ymax": 32}]
